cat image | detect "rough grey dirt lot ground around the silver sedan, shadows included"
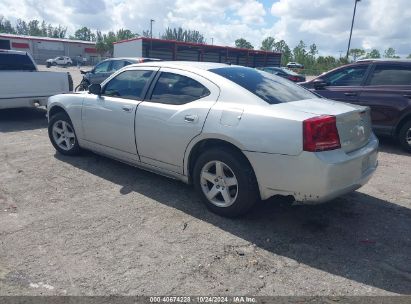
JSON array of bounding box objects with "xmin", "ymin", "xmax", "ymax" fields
[{"xmin": 0, "ymin": 105, "xmax": 411, "ymax": 295}]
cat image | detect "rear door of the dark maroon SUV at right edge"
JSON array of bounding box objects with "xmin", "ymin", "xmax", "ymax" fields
[{"xmin": 358, "ymin": 62, "xmax": 411, "ymax": 134}]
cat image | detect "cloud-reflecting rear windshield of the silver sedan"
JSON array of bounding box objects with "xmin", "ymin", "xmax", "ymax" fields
[{"xmin": 209, "ymin": 67, "xmax": 318, "ymax": 104}]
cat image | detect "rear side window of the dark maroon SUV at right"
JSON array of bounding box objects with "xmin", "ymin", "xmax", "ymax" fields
[{"xmin": 369, "ymin": 64, "xmax": 411, "ymax": 85}]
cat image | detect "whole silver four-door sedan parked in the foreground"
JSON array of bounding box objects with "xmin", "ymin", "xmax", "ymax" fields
[{"xmin": 48, "ymin": 62, "xmax": 378, "ymax": 216}]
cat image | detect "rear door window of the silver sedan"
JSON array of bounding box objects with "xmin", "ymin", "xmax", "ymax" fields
[{"xmin": 151, "ymin": 72, "xmax": 210, "ymax": 105}]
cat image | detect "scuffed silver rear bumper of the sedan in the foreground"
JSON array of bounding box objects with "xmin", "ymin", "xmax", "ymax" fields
[{"xmin": 244, "ymin": 134, "xmax": 378, "ymax": 203}]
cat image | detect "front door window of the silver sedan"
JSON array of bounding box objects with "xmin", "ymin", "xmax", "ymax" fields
[{"xmin": 103, "ymin": 70, "xmax": 153, "ymax": 100}]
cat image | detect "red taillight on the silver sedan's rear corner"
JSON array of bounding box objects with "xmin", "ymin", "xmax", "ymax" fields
[{"xmin": 303, "ymin": 115, "xmax": 341, "ymax": 152}]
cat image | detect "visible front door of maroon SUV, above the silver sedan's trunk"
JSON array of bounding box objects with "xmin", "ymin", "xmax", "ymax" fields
[{"xmin": 312, "ymin": 64, "xmax": 370, "ymax": 103}]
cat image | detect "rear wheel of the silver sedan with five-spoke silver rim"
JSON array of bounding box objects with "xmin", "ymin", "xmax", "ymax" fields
[{"xmin": 193, "ymin": 147, "xmax": 259, "ymax": 217}]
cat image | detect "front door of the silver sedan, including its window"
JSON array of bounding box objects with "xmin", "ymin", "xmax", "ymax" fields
[{"xmin": 82, "ymin": 67, "xmax": 158, "ymax": 162}]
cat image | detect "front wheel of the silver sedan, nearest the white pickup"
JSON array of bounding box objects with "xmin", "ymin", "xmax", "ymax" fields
[{"xmin": 48, "ymin": 112, "xmax": 80, "ymax": 155}]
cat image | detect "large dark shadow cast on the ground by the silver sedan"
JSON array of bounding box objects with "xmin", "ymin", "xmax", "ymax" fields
[{"xmin": 55, "ymin": 152, "xmax": 411, "ymax": 294}]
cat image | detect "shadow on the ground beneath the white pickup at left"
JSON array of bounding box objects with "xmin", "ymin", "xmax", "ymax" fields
[{"xmin": 0, "ymin": 108, "xmax": 47, "ymax": 132}]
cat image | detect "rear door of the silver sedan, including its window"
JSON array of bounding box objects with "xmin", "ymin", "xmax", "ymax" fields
[{"xmin": 135, "ymin": 68, "xmax": 220, "ymax": 173}]
